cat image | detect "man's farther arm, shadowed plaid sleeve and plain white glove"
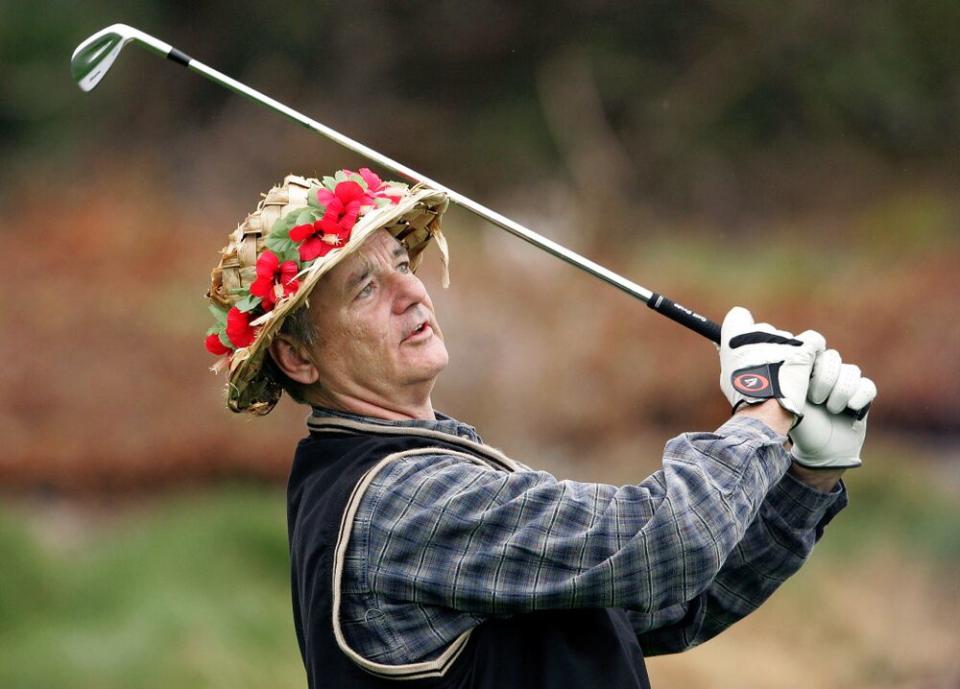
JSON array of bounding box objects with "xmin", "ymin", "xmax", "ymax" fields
[{"xmin": 631, "ymin": 350, "xmax": 876, "ymax": 655}]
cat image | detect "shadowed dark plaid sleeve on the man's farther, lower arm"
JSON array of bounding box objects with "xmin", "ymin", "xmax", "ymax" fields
[{"xmin": 629, "ymin": 422, "xmax": 847, "ymax": 655}]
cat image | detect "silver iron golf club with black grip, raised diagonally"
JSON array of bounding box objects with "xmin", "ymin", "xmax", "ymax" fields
[{"xmin": 70, "ymin": 24, "xmax": 720, "ymax": 344}]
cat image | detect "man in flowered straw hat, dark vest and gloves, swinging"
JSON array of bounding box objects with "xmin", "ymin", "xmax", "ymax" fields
[{"xmin": 207, "ymin": 169, "xmax": 876, "ymax": 687}]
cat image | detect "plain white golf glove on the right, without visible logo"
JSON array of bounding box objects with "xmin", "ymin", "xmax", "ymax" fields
[{"xmin": 790, "ymin": 349, "xmax": 877, "ymax": 469}]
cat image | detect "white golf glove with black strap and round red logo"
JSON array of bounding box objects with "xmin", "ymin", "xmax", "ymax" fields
[{"xmin": 720, "ymin": 306, "xmax": 826, "ymax": 416}]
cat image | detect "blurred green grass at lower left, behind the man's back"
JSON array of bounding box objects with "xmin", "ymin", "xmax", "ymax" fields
[{"xmin": 0, "ymin": 487, "xmax": 304, "ymax": 689}]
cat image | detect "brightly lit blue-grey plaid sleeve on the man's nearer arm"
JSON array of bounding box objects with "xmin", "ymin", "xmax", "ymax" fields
[{"xmin": 355, "ymin": 422, "xmax": 790, "ymax": 615}]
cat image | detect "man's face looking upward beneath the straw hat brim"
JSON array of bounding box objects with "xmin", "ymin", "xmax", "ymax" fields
[{"xmin": 302, "ymin": 230, "xmax": 448, "ymax": 406}]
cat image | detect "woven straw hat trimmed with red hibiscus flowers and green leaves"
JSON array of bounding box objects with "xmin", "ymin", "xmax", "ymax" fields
[{"xmin": 206, "ymin": 168, "xmax": 449, "ymax": 415}]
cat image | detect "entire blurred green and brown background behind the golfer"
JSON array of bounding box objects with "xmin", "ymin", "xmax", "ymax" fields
[{"xmin": 0, "ymin": 0, "xmax": 960, "ymax": 689}]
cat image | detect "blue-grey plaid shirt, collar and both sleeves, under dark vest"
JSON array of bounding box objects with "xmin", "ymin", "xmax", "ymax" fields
[{"xmin": 317, "ymin": 409, "xmax": 847, "ymax": 664}]
